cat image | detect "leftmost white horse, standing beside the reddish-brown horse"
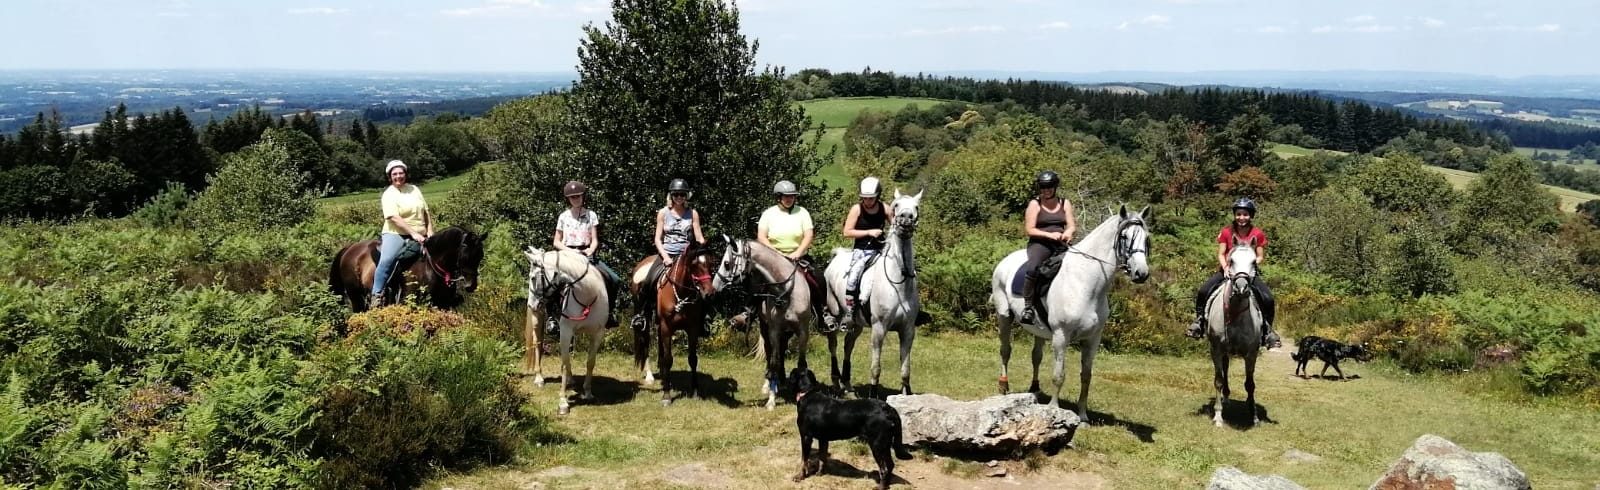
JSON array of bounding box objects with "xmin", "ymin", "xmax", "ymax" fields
[{"xmin": 522, "ymin": 247, "xmax": 611, "ymax": 415}]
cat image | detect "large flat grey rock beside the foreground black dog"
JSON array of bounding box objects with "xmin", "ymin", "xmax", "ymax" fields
[{"xmin": 890, "ymin": 392, "xmax": 1078, "ymax": 453}]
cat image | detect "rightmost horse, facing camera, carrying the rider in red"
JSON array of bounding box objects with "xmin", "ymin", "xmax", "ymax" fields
[{"xmin": 1206, "ymin": 237, "xmax": 1264, "ymax": 428}]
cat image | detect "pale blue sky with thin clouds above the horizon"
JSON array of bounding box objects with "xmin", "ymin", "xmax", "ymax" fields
[{"xmin": 0, "ymin": 0, "xmax": 1600, "ymax": 77}]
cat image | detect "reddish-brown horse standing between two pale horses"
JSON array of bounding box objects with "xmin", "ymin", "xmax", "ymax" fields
[{"xmin": 632, "ymin": 243, "xmax": 717, "ymax": 407}]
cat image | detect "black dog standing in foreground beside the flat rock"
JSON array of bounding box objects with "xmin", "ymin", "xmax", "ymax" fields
[{"xmin": 789, "ymin": 368, "xmax": 910, "ymax": 490}]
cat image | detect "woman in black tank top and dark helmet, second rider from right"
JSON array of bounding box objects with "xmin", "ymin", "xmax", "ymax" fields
[{"xmin": 1021, "ymin": 170, "xmax": 1078, "ymax": 323}]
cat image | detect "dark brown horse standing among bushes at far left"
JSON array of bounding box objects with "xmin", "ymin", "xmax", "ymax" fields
[{"xmin": 328, "ymin": 226, "xmax": 483, "ymax": 312}]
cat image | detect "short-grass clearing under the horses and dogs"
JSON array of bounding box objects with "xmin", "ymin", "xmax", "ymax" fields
[{"xmin": 426, "ymin": 327, "xmax": 1600, "ymax": 490}]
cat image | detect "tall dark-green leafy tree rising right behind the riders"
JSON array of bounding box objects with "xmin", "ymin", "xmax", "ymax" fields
[{"xmin": 547, "ymin": 0, "xmax": 822, "ymax": 259}]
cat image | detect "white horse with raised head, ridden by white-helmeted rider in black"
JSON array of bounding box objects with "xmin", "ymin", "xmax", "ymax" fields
[{"xmin": 822, "ymin": 189, "xmax": 922, "ymax": 397}]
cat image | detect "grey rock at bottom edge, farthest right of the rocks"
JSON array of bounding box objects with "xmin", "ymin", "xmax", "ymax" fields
[{"xmin": 1371, "ymin": 434, "xmax": 1533, "ymax": 490}]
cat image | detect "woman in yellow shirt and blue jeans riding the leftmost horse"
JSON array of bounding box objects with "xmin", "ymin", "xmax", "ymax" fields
[{"xmin": 371, "ymin": 160, "xmax": 434, "ymax": 307}]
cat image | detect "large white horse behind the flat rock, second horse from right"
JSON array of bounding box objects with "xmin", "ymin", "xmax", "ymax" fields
[{"xmin": 990, "ymin": 205, "xmax": 1150, "ymax": 423}]
